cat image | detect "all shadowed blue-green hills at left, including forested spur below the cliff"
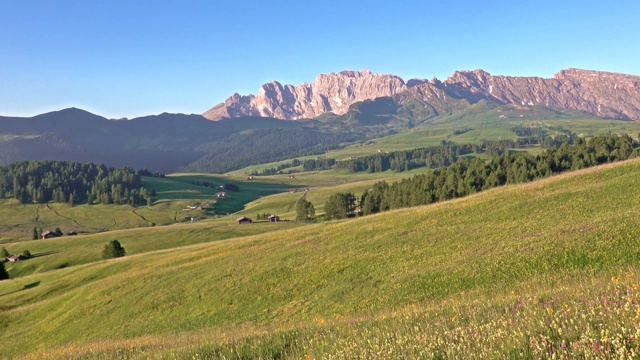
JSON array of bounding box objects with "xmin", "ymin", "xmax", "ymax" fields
[{"xmin": 0, "ymin": 108, "xmax": 371, "ymax": 173}]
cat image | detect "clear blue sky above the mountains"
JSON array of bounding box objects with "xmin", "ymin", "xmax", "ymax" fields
[{"xmin": 0, "ymin": 0, "xmax": 640, "ymax": 118}]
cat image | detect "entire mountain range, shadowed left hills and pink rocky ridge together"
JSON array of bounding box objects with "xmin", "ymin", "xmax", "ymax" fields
[{"xmin": 0, "ymin": 69, "xmax": 640, "ymax": 173}]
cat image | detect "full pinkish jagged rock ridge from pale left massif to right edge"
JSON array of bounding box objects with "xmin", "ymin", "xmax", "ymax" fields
[{"xmin": 203, "ymin": 69, "xmax": 640, "ymax": 121}]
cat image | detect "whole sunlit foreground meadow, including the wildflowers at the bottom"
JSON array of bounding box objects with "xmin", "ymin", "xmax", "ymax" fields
[{"xmin": 0, "ymin": 160, "xmax": 640, "ymax": 359}]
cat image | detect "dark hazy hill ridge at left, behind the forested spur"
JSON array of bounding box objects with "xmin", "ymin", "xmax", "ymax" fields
[{"xmin": 0, "ymin": 108, "xmax": 307, "ymax": 173}]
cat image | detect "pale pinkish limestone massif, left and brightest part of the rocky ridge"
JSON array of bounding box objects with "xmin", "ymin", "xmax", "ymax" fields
[{"xmin": 203, "ymin": 70, "xmax": 407, "ymax": 120}]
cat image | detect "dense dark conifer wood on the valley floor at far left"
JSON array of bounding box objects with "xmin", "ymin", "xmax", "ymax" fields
[{"xmin": 0, "ymin": 160, "xmax": 151, "ymax": 205}]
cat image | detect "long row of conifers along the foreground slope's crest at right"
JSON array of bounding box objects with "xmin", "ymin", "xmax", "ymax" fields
[{"xmin": 325, "ymin": 134, "xmax": 638, "ymax": 219}]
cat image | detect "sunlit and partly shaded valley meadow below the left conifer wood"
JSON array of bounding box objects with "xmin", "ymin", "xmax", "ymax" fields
[{"xmin": 0, "ymin": 174, "xmax": 296, "ymax": 244}]
